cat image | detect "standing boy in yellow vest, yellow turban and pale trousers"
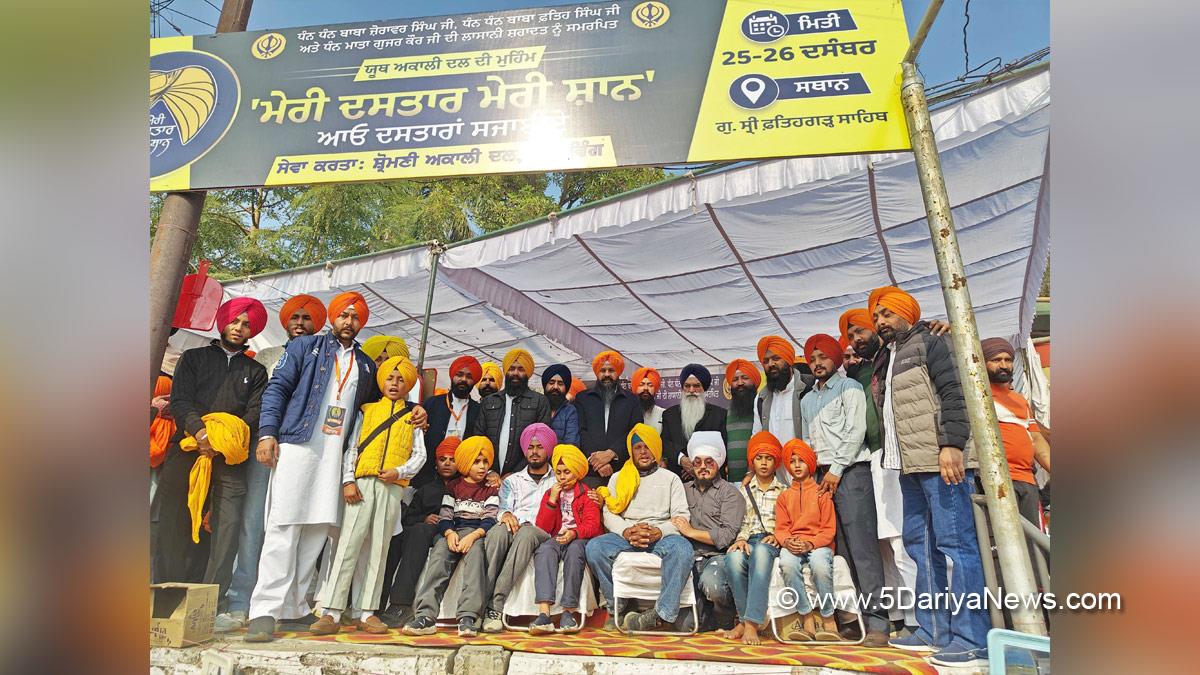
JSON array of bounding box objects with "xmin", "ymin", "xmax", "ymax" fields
[{"xmin": 312, "ymin": 357, "xmax": 425, "ymax": 635}]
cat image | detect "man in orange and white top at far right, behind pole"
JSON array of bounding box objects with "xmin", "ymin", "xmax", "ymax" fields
[{"xmin": 980, "ymin": 338, "xmax": 1050, "ymax": 527}]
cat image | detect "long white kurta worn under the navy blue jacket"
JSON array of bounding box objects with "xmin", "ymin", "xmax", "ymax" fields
[{"xmin": 266, "ymin": 347, "xmax": 361, "ymax": 527}]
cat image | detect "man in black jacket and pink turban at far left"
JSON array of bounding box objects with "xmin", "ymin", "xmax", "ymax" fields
[{"xmin": 155, "ymin": 298, "xmax": 266, "ymax": 609}]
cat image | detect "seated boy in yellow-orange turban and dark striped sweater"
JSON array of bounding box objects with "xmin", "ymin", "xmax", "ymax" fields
[{"xmin": 403, "ymin": 436, "xmax": 500, "ymax": 638}]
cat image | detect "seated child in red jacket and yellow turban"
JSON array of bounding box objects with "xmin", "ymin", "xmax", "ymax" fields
[{"xmin": 529, "ymin": 444, "xmax": 604, "ymax": 634}]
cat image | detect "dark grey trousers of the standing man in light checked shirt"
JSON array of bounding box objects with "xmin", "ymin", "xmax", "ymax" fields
[{"xmin": 815, "ymin": 461, "xmax": 888, "ymax": 633}]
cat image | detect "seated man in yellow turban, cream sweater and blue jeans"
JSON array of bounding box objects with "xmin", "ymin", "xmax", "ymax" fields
[{"xmin": 587, "ymin": 423, "xmax": 692, "ymax": 631}]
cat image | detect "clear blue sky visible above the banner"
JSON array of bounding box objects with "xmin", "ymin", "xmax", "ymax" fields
[{"xmin": 154, "ymin": 0, "xmax": 1050, "ymax": 85}]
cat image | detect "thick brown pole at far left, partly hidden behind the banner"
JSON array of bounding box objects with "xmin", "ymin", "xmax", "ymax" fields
[{"xmin": 150, "ymin": 0, "xmax": 253, "ymax": 390}]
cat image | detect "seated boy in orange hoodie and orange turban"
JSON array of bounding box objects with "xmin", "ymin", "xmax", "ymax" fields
[{"xmin": 775, "ymin": 438, "xmax": 841, "ymax": 641}]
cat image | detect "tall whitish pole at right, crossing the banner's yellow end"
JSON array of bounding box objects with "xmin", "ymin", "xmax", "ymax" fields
[{"xmin": 900, "ymin": 0, "xmax": 1048, "ymax": 635}]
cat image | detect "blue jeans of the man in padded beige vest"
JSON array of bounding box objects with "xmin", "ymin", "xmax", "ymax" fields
[{"xmin": 900, "ymin": 471, "xmax": 991, "ymax": 649}]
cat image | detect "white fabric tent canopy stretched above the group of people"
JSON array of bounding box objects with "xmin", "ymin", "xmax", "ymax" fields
[{"xmin": 226, "ymin": 71, "xmax": 1050, "ymax": 375}]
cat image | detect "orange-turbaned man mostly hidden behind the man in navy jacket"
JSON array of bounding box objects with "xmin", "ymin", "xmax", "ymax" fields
[{"xmin": 212, "ymin": 293, "xmax": 326, "ymax": 633}]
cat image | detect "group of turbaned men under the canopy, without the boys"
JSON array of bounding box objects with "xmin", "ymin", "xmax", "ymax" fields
[{"xmin": 151, "ymin": 281, "xmax": 1049, "ymax": 665}]
